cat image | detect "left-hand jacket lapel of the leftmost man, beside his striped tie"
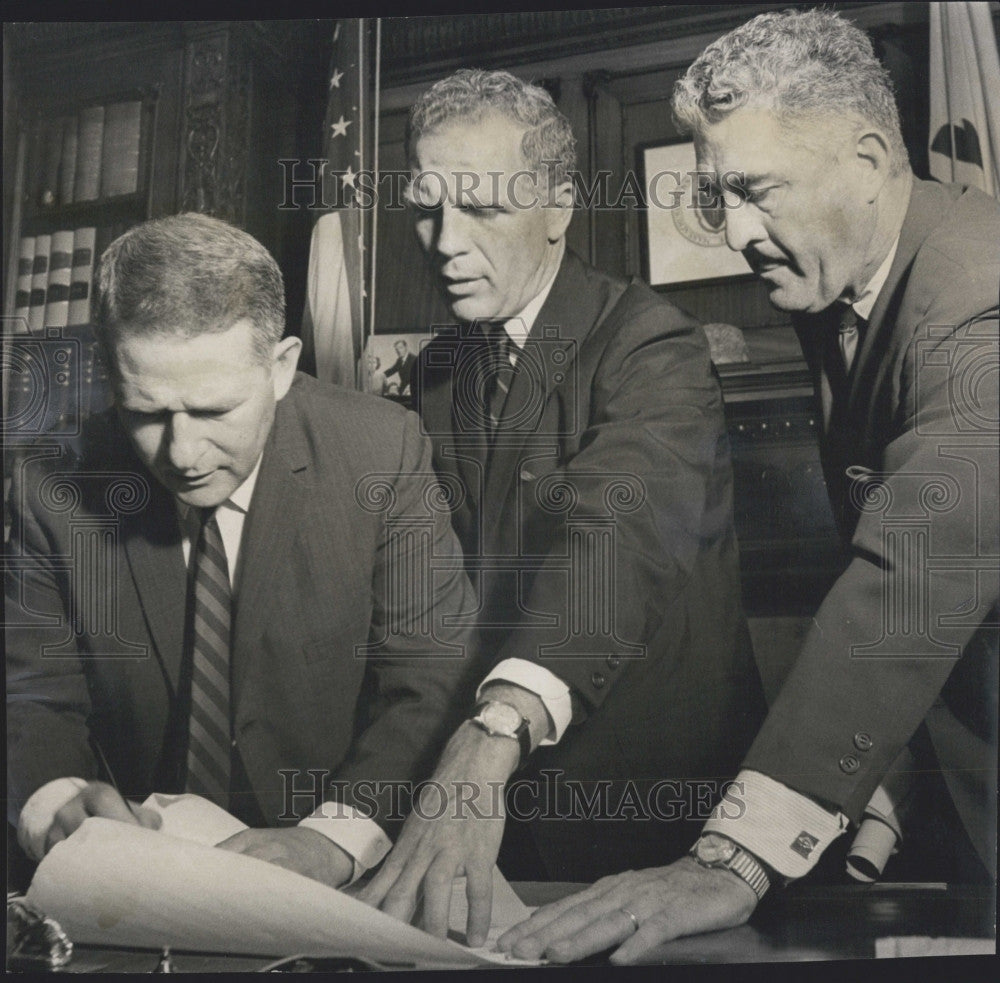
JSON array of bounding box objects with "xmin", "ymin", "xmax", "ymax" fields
[{"xmin": 121, "ymin": 479, "xmax": 187, "ymax": 694}]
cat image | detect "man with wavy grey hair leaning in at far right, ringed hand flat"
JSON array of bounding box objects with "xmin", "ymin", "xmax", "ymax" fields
[{"xmin": 501, "ymin": 5, "xmax": 1000, "ymax": 962}]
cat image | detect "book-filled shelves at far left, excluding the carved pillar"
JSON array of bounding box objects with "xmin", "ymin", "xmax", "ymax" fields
[{"xmin": 4, "ymin": 88, "xmax": 158, "ymax": 446}]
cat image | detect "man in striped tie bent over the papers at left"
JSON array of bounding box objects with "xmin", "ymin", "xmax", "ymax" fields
[{"xmin": 6, "ymin": 215, "xmax": 471, "ymax": 886}]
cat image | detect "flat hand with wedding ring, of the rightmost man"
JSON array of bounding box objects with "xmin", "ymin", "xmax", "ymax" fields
[{"xmin": 497, "ymin": 857, "xmax": 757, "ymax": 965}]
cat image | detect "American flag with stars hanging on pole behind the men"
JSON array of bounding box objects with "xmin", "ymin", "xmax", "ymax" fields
[{"xmin": 302, "ymin": 18, "xmax": 373, "ymax": 388}]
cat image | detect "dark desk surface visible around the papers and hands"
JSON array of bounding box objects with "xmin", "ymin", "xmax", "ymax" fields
[{"xmin": 15, "ymin": 883, "xmax": 996, "ymax": 973}]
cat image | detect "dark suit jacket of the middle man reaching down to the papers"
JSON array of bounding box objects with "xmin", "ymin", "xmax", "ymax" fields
[{"xmin": 414, "ymin": 254, "xmax": 763, "ymax": 880}]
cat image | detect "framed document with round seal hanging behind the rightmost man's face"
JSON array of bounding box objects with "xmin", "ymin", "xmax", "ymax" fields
[{"xmin": 636, "ymin": 140, "xmax": 753, "ymax": 287}]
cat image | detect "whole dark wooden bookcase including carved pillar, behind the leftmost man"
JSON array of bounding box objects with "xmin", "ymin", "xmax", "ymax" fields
[{"xmin": 2, "ymin": 21, "xmax": 324, "ymax": 479}]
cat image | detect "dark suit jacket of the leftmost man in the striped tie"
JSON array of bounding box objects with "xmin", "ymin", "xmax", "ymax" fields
[{"xmin": 6, "ymin": 375, "xmax": 478, "ymax": 829}]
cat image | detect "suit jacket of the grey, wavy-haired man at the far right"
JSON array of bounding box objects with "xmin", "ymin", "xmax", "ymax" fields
[{"xmin": 746, "ymin": 181, "xmax": 1000, "ymax": 870}]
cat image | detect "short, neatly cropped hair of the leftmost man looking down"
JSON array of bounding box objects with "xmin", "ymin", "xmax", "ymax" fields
[{"xmin": 95, "ymin": 212, "xmax": 285, "ymax": 363}]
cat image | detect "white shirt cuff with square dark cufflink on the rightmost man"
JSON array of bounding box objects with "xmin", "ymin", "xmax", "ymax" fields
[{"xmin": 705, "ymin": 770, "xmax": 848, "ymax": 878}]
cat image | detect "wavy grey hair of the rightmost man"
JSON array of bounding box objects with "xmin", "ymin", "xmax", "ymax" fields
[{"xmin": 672, "ymin": 10, "xmax": 909, "ymax": 174}]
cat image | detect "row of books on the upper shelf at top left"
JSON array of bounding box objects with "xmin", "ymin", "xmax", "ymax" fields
[{"xmin": 28, "ymin": 100, "xmax": 142, "ymax": 209}]
